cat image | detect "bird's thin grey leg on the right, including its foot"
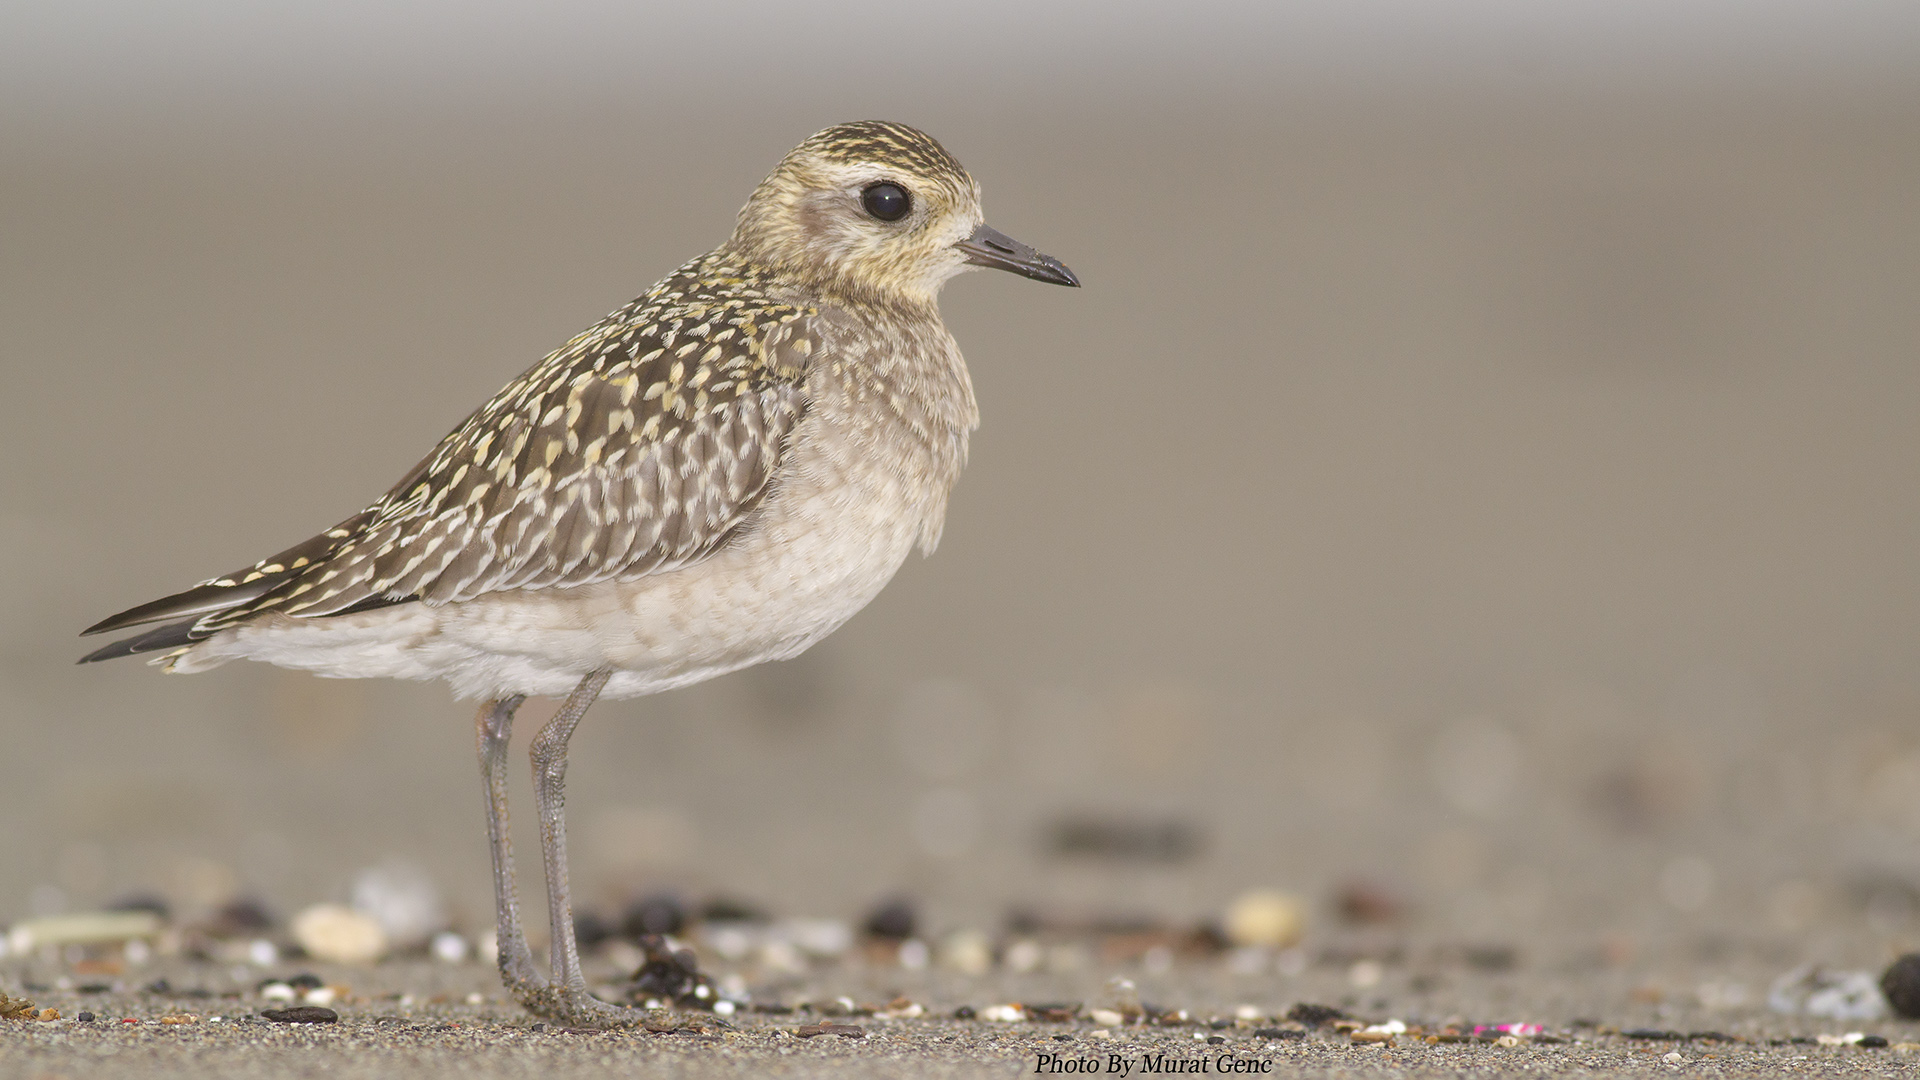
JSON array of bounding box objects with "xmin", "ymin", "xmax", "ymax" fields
[{"xmin": 532, "ymin": 671, "xmax": 643, "ymax": 1026}]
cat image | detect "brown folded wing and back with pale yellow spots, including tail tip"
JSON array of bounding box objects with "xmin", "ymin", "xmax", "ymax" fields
[{"xmin": 88, "ymin": 256, "xmax": 818, "ymax": 659}]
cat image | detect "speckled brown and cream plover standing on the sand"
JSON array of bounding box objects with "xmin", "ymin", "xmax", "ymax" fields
[{"xmin": 81, "ymin": 121, "xmax": 1079, "ymax": 1026}]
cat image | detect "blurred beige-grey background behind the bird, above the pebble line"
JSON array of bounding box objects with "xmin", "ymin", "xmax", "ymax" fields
[{"xmin": 0, "ymin": 0, "xmax": 1920, "ymax": 957}]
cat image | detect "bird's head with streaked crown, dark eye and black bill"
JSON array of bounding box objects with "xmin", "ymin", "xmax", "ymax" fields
[{"xmin": 730, "ymin": 121, "xmax": 1079, "ymax": 304}]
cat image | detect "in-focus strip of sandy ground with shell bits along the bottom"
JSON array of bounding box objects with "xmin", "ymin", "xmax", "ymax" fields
[{"xmin": 0, "ymin": 942, "xmax": 1920, "ymax": 1078}]
